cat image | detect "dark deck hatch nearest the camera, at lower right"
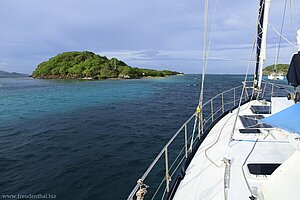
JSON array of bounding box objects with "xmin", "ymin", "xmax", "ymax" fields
[{"xmin": 247, "ymin": 163, "xmax": 281, "ymax": 175}]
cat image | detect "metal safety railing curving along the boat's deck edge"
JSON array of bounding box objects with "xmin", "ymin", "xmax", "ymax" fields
[{"xmin": 127, "ymin": 82, "xmax": 291, "ymax": 200}]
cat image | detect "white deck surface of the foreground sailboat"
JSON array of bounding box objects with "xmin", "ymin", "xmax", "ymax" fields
[{"xmin": 174, "ymin": 100, "xmax": 296, "ymax": 200}]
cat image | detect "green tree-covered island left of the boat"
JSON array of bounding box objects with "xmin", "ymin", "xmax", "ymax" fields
[{"xmin": 32, "ymin": 51, "xmax": 180, "ymax": 79}]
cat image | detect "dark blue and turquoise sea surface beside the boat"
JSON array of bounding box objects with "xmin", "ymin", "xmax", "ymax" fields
[{"xmin": 0, "ymin": 75, "xmax": 278, "ymax": 200}]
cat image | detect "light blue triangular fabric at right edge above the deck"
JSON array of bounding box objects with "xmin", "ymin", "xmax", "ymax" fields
[{"xmin": 260, "ymin": 103, "xmax": 300, "ymax": 135}]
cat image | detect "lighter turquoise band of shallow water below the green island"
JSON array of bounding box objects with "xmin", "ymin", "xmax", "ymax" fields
[{"xmin": 0, "ymin": 78, "xmax": 164, "ymax": 122}]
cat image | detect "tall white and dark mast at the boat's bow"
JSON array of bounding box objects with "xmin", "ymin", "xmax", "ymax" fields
[{"xmin": 254, "ymin": 0, "xmax": 270, "ymax": 89}]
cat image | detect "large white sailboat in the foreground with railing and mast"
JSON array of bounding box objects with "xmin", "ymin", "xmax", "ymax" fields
[{"xmin": 127, "ymin": 0, "xmax": 300, "ymax": 200}]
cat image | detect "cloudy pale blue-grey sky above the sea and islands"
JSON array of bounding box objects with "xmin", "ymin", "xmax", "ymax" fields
[{"xmin": 0, "ymin": 0, "xmax": 300, "ymax": 74}]
